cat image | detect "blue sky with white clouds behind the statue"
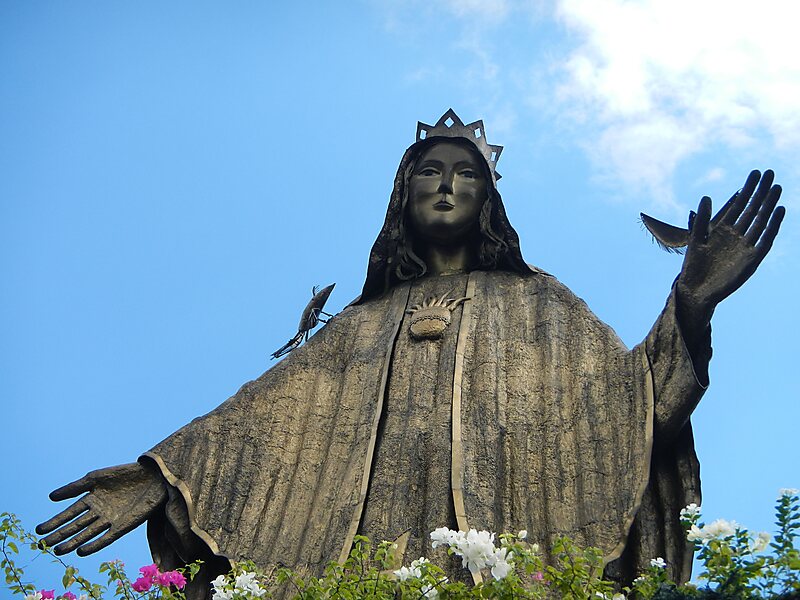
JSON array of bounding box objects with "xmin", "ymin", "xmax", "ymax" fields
[{"xmin": 0, "ymin": 0, "xmax": 800, "ymax": 587}]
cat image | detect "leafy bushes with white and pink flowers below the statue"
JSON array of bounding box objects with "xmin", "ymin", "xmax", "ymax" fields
[{"xmin": 0, "ymin": 489, "xmax": 800, "ymax": 600}]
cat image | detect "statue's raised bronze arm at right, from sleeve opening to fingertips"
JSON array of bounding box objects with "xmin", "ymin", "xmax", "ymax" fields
[{"xmin": 646, "ymin": 171, "xmax": 785, "ymax": 440}]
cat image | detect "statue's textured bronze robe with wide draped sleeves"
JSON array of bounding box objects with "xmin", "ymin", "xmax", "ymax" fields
[{"xmin": 141, "ymin": 270, "xmax": 705, "ymax": 592}]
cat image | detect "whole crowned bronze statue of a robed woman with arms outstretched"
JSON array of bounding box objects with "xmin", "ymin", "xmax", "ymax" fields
[{"xmin": 37, "ymin": 110, "xmax": 784, "ymax": 597}]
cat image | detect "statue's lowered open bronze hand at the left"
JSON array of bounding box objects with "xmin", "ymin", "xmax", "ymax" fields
[{"xmin": 36, "ymin": 463, "xmax": 167, "ymax": 556}]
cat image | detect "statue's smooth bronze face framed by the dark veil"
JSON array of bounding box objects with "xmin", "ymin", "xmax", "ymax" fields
[{"xmin": 408, "ymin": 142, "xmax": 487, "ymax": 245}]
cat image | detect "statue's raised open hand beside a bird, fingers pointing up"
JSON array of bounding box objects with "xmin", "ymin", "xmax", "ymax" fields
[{"xmin": 676, "ymin": 170, "xmax": 786, "ymax": 320}]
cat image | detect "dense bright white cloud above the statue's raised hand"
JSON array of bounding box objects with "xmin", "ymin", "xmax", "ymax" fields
[{"xmin": 556, "ymin": 0, "xmax": 800, "ymax": 209}]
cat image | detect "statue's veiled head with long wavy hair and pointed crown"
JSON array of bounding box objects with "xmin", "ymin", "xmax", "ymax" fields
[{"xmin": 359, "ymin": 110, "xmax": 532, "ymax": 302}]
